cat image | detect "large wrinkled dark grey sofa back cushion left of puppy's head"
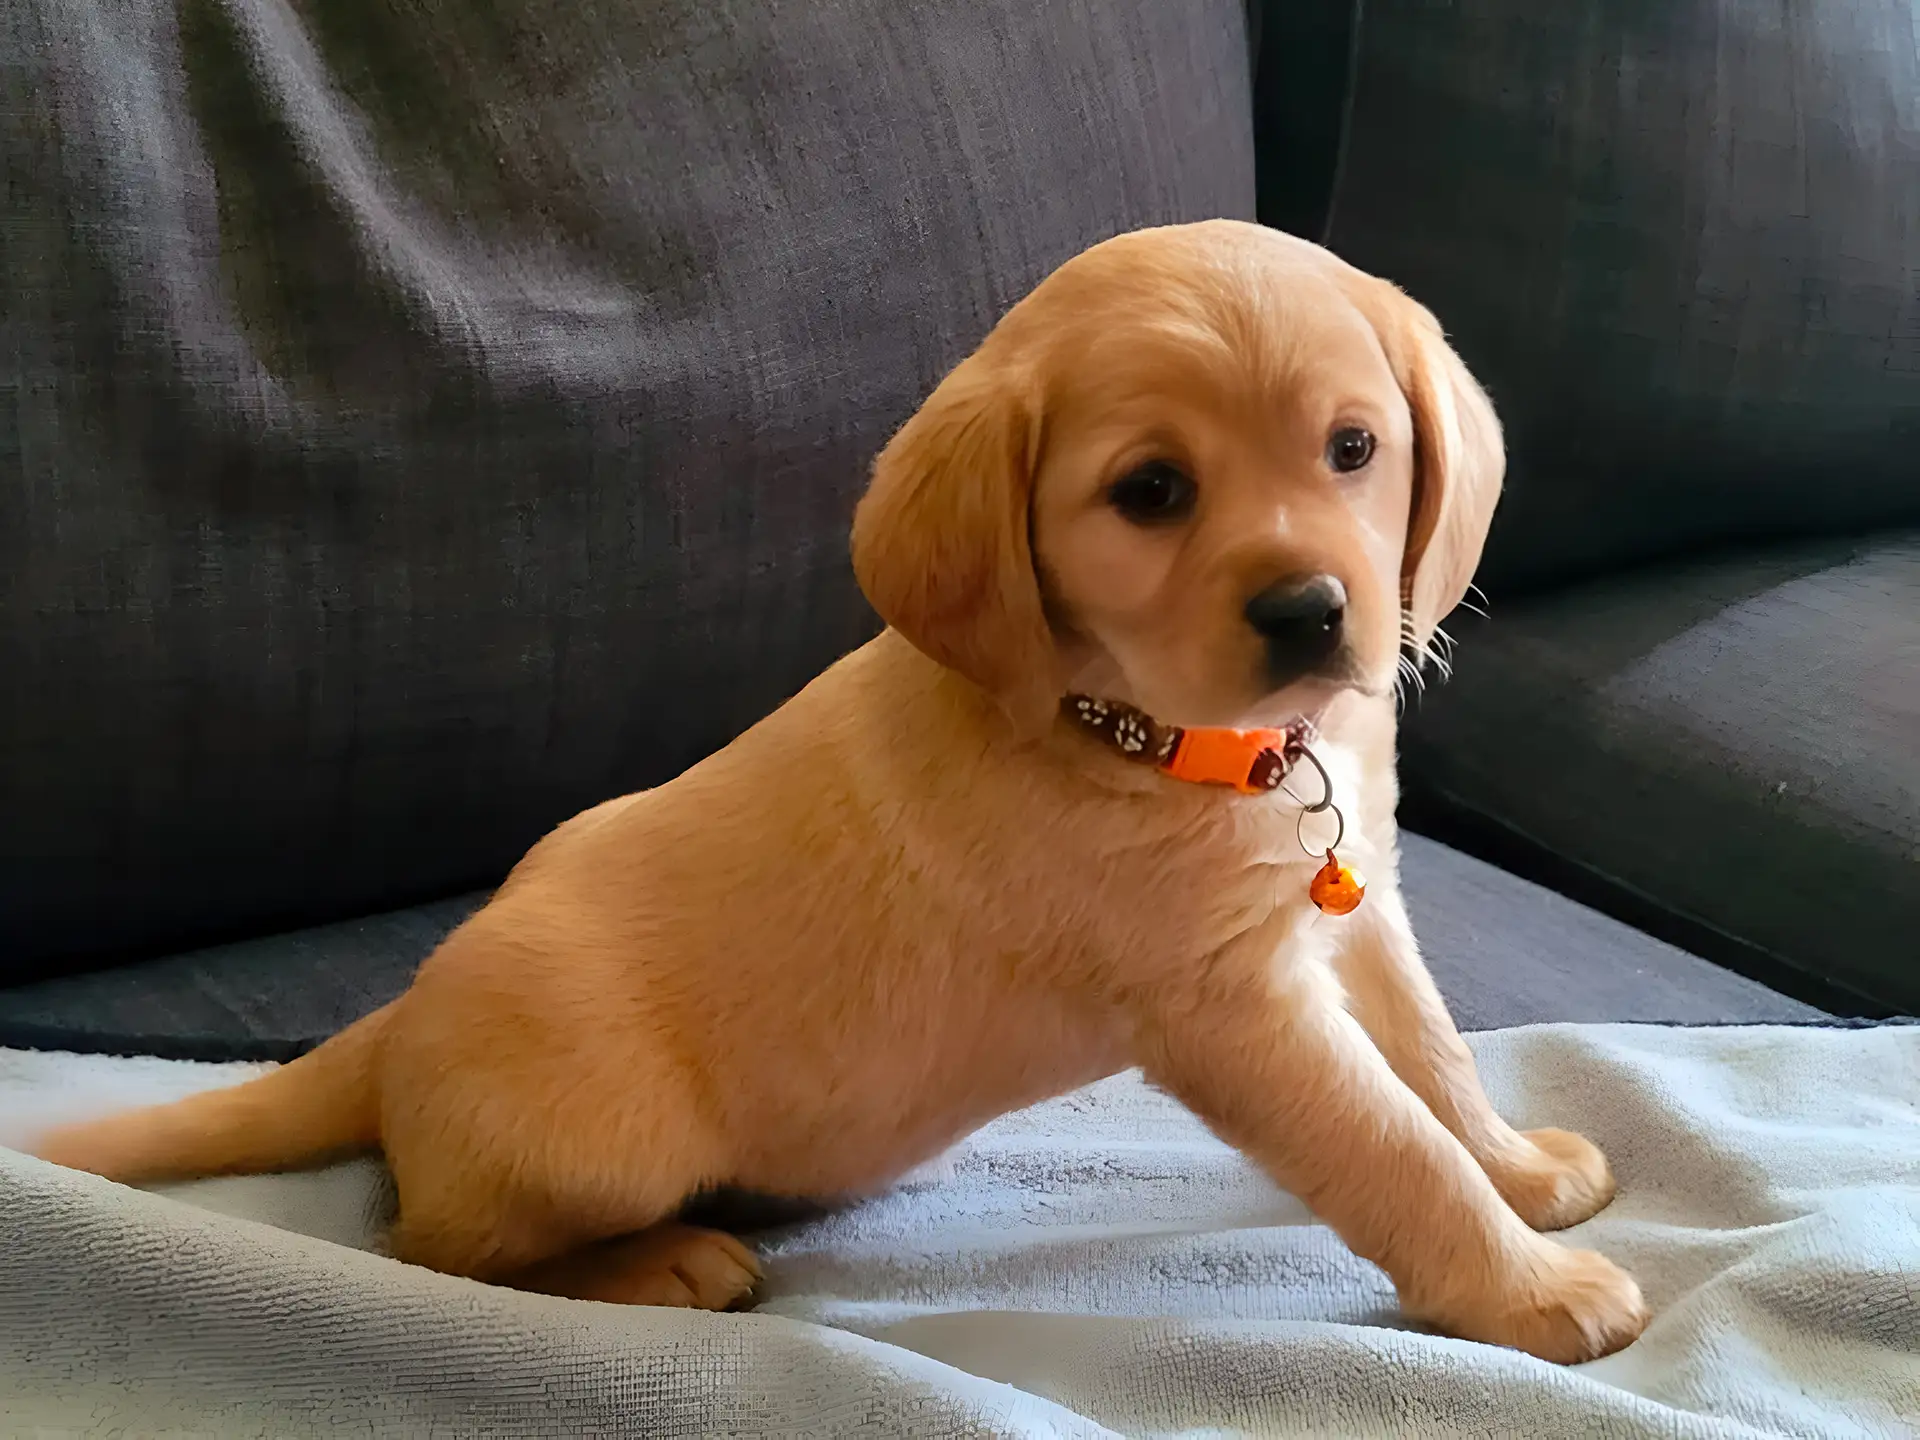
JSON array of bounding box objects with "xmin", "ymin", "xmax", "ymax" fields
[{"xmin": 0, "ymin": 0, "xmax": 1254, "ymax": 979}]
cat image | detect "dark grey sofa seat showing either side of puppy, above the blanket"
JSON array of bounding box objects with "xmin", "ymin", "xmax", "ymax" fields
[{"xmin": 0, "ymin": 835, "xmax": 1820, "ymax": 1060}]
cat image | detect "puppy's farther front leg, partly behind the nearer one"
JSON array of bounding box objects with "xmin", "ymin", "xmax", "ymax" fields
[{"xmin": 1334, "ymin": 885, "xmax": 1613, "ymax": 1231}]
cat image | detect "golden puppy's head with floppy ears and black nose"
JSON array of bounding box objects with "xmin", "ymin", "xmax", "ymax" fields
[{"xmin": 854, "ymin": 221, "xmax": 1503, "ymax": 732}]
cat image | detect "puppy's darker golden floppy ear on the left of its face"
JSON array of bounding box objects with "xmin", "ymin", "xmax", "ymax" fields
[{"xmin": 852, "ymin": 355, "xmax": 1060, "ymax": 733}]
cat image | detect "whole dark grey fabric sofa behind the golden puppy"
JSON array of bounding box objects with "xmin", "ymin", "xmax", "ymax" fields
[{"xmin": 0, "ymin": 0, "xmax": 1920, "ymax": 1058}]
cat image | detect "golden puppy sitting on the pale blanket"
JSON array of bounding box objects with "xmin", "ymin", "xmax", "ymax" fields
[{"xmin": 38, "ymin": 221, "xmax": 1647, "ymax": 1361}]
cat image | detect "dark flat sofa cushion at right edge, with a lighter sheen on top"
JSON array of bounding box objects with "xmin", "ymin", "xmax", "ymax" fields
[{"xmin": 1402, "ymin": 536, "xmax": 1920, "ymax": 1012}]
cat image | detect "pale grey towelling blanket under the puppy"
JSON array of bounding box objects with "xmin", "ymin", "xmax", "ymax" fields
[{"xmin": 0, "ymin": 1027, "xmax": 1920, "ymax": 1440}]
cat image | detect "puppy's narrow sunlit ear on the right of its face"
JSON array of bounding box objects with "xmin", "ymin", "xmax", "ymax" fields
[{"xmin": 1394, "ymin": 299, "xmax": 1507, "ymax": 664}]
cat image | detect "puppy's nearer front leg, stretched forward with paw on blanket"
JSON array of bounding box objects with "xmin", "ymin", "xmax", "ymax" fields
[{"xmin": 1146, "ymin": 987, "xmax": 1647, "ymax": 1363}]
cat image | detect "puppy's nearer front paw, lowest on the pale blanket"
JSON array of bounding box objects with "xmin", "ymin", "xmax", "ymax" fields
[{"xmin": 1430, "ymin": 1242, "xmax": 1651, "ymax": 1365}]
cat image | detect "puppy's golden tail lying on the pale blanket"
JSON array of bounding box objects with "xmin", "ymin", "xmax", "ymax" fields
[{"xmin": 29, "ymin": 1004, "xmax": 394, "ymax": 1185}]
